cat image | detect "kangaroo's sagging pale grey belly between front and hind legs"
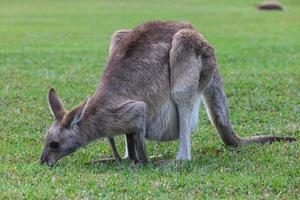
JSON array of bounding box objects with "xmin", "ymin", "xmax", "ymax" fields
[{"xmin": 146, "ymin": 99, "xmax": 179, "ymax": 141}]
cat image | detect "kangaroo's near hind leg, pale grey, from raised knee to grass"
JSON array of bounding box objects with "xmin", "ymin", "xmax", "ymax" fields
[{"xmin": 170, "ymin": 29, "xmax": 214, "ymax": 160}]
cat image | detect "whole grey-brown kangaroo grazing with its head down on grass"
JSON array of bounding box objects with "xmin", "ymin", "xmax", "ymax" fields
[{"xmin": 40, "ymin": 21, "xmax": 296, "ymax": 166}]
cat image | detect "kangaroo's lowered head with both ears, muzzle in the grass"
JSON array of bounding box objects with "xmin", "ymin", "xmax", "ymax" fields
[{"xmin": 40, "ymin": 88, "xmax": 88, "ymax": 166}]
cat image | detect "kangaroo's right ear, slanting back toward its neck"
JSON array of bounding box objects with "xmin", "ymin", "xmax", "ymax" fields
[{"xmin": 62, "ymin": 98, "xmax": 90, "ymax": 128}]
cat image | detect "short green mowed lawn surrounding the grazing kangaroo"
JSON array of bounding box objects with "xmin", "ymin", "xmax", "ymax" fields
[{"xmin": 0, "ymin": 0, "xmax": 300, "ymax": 199}]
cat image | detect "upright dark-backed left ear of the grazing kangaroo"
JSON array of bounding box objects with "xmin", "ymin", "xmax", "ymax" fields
[{"xmin": 48, "ymin": 88, "xmax": 65, "ymax": 121}]
